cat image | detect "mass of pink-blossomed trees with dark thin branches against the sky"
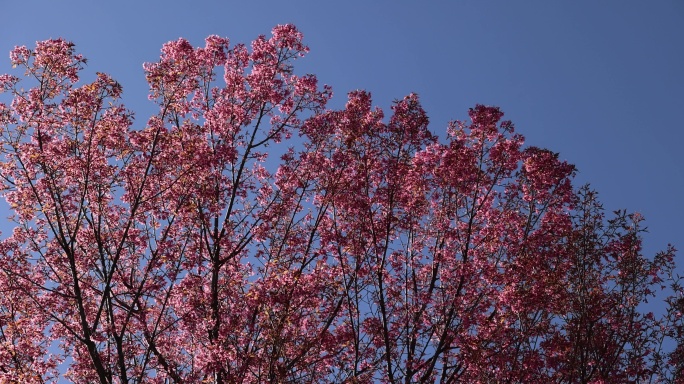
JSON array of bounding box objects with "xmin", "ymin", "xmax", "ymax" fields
[{"xmin": 0, "ymin": 25, "xmax": 684, "ymax": 384}]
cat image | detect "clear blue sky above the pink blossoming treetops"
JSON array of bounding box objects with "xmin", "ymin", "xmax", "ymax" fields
[{"xmin": 0, "ymin": 0, "xmax": 684, "ymax": 265}]
